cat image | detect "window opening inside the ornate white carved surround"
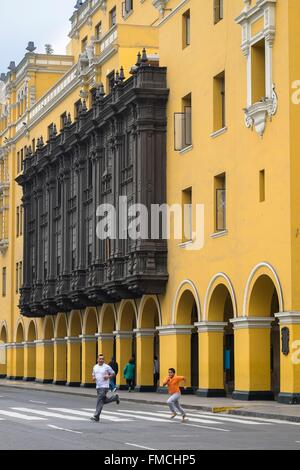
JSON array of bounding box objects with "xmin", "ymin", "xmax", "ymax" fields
[{"xmin": 251, "ymin": 39, "xmax": 266, "ymax": 104}]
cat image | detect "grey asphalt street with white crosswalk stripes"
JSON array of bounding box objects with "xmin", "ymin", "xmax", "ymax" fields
[{"xmin": 0, "ymin": 387, "xmax": 300, "ymax": 451}]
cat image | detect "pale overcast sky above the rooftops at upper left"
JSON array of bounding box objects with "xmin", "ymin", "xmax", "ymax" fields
[{"xmin": 0, "ymin": 0, "xmax": 76, "ymax": 73}]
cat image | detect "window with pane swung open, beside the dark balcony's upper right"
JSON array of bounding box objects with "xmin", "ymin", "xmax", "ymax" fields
[{"xmin": 174, "ymin": 93, "xmax": 192, "ymax": 151}]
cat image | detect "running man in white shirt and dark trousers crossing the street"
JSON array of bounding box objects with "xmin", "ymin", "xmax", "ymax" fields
[{"xmin": 91, "ymin": 354, "xmax": 120, "ymax": 422}]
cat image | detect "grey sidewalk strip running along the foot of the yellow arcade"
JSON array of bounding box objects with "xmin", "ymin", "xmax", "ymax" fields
[{"xmin": 0, "ymin": 379, "xmax": 300, "ymax": 423}]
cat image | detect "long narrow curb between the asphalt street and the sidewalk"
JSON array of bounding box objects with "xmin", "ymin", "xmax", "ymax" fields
[{"xmin": 0, "ymin": 381, "xmax": 300, "ymax": 423}]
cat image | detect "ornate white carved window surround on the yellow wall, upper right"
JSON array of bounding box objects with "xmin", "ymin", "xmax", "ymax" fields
[{"xmin": 235, "ymin": 0, "xmax": 278, "ymax": 137}]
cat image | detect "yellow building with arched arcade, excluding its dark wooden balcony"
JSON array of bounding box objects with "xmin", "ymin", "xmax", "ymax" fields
[{"xmin": 0, "ymin": 0, "xmax": 300, "ymax": 404}]
